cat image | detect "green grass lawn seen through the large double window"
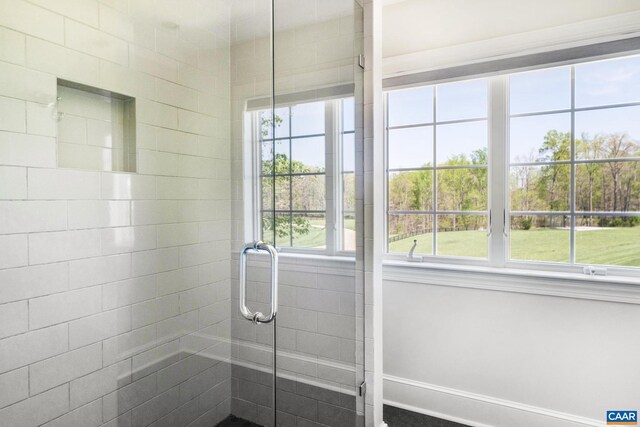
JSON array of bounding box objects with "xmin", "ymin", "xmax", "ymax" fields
[{"xmin": 389, "ymin": 227, "xmax": 640, "ymax": 266}]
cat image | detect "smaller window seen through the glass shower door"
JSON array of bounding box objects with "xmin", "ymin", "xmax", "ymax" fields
[{"xmin": 253, "ymin": 98, "xmax": 355, "ymax": 254}]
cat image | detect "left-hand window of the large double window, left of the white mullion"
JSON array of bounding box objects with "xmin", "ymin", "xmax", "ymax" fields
[{"xmin": 387, "ymin": 79, "xmax": 488, "ymax": 258}]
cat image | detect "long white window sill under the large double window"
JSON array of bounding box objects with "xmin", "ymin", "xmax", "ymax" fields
[{"xmin": 383, "ymin": 260, "xmax": 640, "ymax": 304}]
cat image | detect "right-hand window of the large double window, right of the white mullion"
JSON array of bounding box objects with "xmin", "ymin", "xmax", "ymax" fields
[{"xmin": 509, "ymin": 57, "xmax": 640, "ymax": 266}]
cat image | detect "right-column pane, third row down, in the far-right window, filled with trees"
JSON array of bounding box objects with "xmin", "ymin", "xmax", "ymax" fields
[{"xmin": 575, "ymin": 162, "xmax": 640, "ymax": 212}]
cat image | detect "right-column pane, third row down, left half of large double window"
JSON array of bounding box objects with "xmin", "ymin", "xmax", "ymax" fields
[{"xmin": 436, "ymin": 168, "xmax": 488, "ymax": 212}]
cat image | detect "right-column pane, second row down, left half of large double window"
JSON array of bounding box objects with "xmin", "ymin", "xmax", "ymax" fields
[{"xmin": 436, "ymin": 120, "xmax": 488, "ymax": 166}]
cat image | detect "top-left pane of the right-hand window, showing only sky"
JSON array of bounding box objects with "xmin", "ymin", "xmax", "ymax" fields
[{"xmin": 509, "ymin": 67, "xmax": 571, "ymax": 114}]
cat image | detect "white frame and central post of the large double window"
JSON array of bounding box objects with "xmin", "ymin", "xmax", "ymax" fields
[{"xmin": 382, "ymin": 50, "xmax": 640, "ymax": 278}]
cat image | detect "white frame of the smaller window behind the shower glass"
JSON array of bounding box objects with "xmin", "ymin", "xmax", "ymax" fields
[{"xmin": 244, "ymin": 96, "xmax": 355, "ymax": 257}]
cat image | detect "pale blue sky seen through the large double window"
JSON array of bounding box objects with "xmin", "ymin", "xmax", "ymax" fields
[{"xmin": 389, "ymin": 56, "xmax": 640, "ymax": 168}]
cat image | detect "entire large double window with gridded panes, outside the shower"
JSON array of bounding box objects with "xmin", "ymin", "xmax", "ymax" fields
[{"xmin": 386, "ymin": 56, "xmax": 640, "ymax": 273}]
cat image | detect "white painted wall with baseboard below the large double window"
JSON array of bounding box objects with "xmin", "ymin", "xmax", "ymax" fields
[{"xmin": 384, "ymin": 273, "xmax": 640, "ymax": 426}]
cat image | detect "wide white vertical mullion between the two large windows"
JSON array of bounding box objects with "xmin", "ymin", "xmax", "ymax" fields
[{"xmin": 488, "ymin": 76, "xmax": 509, "ymax": 267}]
